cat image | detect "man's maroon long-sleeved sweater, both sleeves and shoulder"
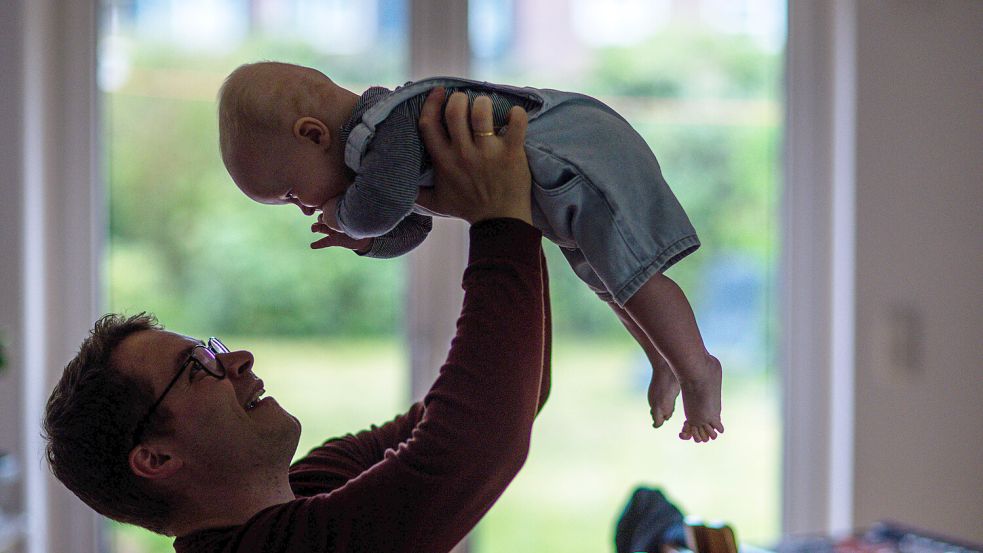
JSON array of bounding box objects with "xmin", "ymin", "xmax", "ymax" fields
[{"xmin": 174, "ymin": 219, "xmax": 550, "ymax": 553}]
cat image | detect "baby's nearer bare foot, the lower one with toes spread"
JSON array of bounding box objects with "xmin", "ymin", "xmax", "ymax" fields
[{"xmin": 679, "ymin": 354, "xmax": 724, "ymax": 443}]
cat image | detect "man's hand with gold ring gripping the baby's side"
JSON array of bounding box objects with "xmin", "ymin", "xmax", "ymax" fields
[{"xmin": 417, "ymin": 88, "xmax": 532, "ymax": 224}]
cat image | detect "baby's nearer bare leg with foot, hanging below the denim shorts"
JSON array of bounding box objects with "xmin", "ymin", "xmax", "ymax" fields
[{"xmin": 625, "ymin": 273, "xmax": 724, "ymax": 442}]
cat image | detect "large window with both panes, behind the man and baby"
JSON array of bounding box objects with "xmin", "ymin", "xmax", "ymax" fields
[{"xmin": 99, "ymin": 0, "xmax": 784, "ymax": 553}]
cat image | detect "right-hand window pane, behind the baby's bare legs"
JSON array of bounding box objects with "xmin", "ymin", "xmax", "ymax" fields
[{"xmin": 469, "ymin": 0, "xmax": 785, "ymax": 553}]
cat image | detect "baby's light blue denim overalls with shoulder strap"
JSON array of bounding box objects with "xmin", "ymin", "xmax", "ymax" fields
[{"xmin": 345, "ymin": 77, "xmax": 700, "ymax": 306}]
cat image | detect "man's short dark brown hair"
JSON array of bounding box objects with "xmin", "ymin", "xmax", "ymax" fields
[{"xmin": 44, "ymin": 313, "xmax": 172, "ymax": 533}]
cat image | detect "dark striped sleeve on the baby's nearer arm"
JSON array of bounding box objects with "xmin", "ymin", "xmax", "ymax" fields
[{"xmin": 337, "ymin": 112, "xmax": 423, "ymax": 238}]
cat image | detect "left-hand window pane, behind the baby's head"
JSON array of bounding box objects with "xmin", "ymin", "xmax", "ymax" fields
[{"xmin": 99, "ymin": 0, "xmax": 409, "ymax": 552}]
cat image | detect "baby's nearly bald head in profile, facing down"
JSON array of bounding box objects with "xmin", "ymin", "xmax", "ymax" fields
[{"xmin": 218, "ymin": 62, "xmax": 358, "ymax": 215}]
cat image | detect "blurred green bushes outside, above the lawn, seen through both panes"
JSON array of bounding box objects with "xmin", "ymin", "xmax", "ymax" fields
[{"xmin": 105, "ymin": 28, "xmax": 780, "ymax": 350}]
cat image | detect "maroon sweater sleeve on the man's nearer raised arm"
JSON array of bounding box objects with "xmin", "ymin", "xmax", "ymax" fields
[{"xmin": 320, "ymin": 220, "xmax": 544, "ymax": 552}]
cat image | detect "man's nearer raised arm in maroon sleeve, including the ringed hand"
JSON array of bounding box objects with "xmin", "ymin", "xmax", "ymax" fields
[{"xmin": 258, "ymin": 91, "xmax": 547, "ymax": 551}]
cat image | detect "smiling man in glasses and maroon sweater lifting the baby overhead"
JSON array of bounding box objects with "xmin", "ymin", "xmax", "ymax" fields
[{"xmin": 45, "ymin": 88, "xmax": 550, "ymax": 552}]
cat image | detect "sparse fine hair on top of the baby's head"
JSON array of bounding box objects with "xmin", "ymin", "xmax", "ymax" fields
[{"xmin": 218, "ymin": 61, "xmax": 333, "ymax": 167}]
